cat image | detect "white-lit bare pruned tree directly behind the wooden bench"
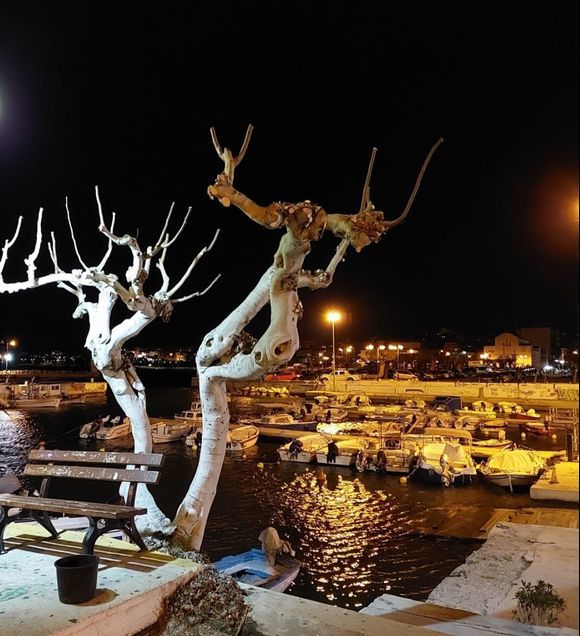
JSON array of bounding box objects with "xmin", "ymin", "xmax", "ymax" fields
[{"xmin": 0, "ymin": 189, "xmax": 219, "ymax": 533}]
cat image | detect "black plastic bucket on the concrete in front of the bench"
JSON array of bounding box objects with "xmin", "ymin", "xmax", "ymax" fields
[{"xmin": 54, "ymin": 554, "xmax": 99, "ymax": 605}]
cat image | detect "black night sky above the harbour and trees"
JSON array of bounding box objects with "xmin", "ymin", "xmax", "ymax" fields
[{"xmin": 0, "ymin": 0, "xmax": 579, "ymax": 349}]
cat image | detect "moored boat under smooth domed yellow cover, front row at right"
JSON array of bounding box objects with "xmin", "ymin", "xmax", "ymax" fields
[{"xmin": 477, "ymin": 448, "xmax": 546, "ymax": 492}]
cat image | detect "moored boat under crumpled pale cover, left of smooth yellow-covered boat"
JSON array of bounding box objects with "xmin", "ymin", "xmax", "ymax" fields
[{"xmin": 413, "ymin": 428, "xmax": 477, "ymax": 486}]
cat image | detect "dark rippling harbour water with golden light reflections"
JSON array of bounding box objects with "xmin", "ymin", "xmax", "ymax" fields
[{"xmin": 0, "ymin": 380, "xmax": 568, "ymax": 609}]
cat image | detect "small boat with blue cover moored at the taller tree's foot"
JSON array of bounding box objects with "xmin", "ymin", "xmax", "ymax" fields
[{"xmin": 213, "ymin": 548, "xmax": 301, "ymax": 592}]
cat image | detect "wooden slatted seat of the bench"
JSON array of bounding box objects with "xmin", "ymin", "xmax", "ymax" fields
[{"xmin": 0, "ymin": 495, "xmax": 147, "ymax": 519}]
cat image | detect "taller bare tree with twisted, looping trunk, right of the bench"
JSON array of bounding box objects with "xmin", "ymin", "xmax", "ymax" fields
[{"xmin": 173, "ymin": 126, "xmax": 443, "ymax": 550}]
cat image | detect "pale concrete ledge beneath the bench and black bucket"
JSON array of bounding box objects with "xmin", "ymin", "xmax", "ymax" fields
[{"xmin": 0, "ymin": 523, "xmax": 202, "ymax": 636}]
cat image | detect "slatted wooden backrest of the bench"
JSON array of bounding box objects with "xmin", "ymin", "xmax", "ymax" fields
[{"xmin": 24, "ymin": 450, "xmax": 165, "ymax": 505}]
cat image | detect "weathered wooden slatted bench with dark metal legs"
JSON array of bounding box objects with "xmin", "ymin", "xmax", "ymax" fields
[{"xmin": 0, "ymin": 450, "xmax": 164, "ymax": 554}]
